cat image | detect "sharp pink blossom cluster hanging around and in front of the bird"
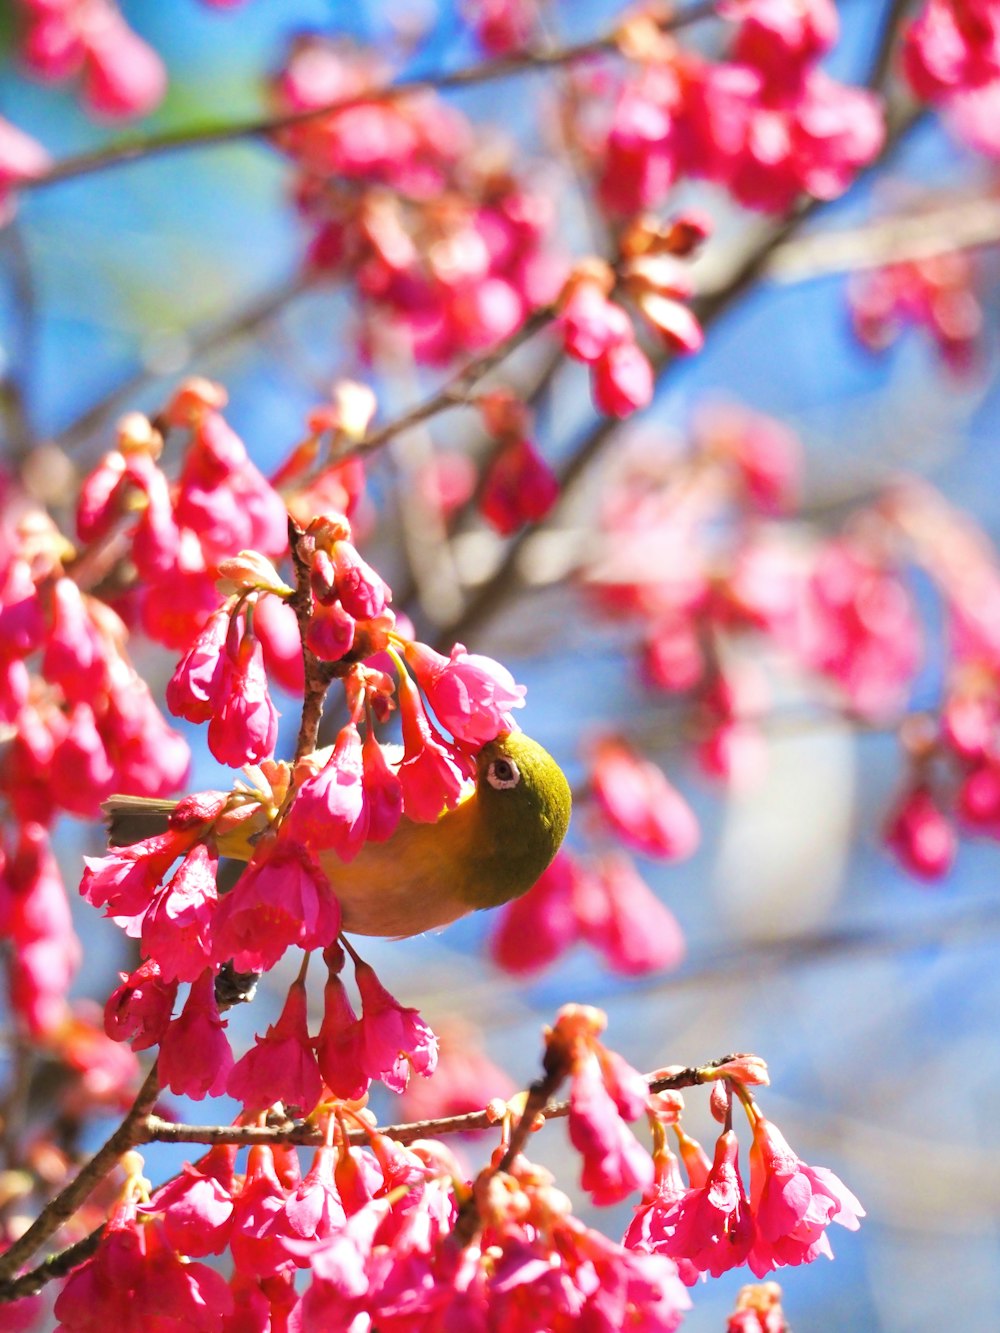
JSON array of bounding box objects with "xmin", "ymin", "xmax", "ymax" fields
[{"xmin": 73, "ymin": 384, "xmax": 524, "ymax": 1114}]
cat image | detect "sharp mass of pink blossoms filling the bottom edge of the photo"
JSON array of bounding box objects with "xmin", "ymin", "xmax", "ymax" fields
[{"xmin": 39, "ymin": 1005, "xmax": 863, "ymax": 1333}]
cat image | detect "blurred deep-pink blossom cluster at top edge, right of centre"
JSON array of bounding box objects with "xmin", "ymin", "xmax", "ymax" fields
[{"xmin": 583, "ymin": 0, "xmax": 885, "ymax": 216}]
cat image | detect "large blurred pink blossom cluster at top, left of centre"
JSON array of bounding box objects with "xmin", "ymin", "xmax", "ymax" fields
[{"xmin": 273, "ymin": 37, "xmax": 565, "ymax": 364}]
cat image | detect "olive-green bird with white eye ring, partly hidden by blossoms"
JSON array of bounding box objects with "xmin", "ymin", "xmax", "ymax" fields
[{"xmin": 104, "ymin": 732, "xmax": 572, "ymax": 938}]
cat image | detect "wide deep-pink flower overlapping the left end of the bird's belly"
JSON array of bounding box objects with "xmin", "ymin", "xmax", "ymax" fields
[{"xmin": 215, "ymin": 837, "xmax": 340, "ymax": 972}]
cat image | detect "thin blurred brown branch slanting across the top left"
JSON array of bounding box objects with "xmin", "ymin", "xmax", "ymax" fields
[{"xmin": 19, "ymin": 0, "xmax": 717, "ymax": 191}]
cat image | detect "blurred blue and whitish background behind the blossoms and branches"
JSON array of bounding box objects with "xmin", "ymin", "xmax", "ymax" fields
[{"xmin": 0, "ymin": 0, "xmax": 1000, "ymax": 1333}]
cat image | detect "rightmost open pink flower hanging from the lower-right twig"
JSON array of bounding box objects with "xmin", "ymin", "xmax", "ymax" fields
[{"xmin": 749, "ymin": 1116, "xmax": 864, "ymax": 1277}]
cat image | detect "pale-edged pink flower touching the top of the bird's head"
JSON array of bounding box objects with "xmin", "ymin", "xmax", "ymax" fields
[{"xmin": 405, "ymin": 641, "xmax": 525, "ymax": 745}]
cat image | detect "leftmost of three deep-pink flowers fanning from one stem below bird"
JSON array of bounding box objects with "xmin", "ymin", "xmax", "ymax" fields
[{"xmin": 225, "ymin": 981, "xmax": 323, "ymax": 1116}]
